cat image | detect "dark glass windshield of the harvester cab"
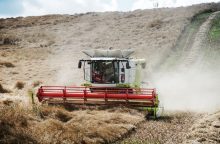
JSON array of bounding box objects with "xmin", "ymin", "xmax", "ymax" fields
[{"xmin": 92, "ymin": 61, "xmax": 119, "ymax": 83}]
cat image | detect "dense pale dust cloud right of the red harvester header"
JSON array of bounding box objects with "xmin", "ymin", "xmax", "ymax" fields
[{"xmin": 153, "ymin": 69, "xmax": 220, "ymax": 112}]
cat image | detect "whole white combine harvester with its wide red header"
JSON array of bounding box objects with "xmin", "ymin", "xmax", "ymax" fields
[{"xmin": 37, "ymin": 50, "xmax": 162, "ymax": 117}]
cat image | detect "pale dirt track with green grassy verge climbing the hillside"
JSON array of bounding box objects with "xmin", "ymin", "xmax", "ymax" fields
[{"xmin": 159, "ymin": 12, "xmax": 219, "ymax": 71}]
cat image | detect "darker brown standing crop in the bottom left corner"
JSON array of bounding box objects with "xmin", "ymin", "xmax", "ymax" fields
[{"xmin": 0, "ymin": 102, "xmax": 36, "ymax": 143}]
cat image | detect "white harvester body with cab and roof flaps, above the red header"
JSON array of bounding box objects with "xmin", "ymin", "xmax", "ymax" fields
[{"xmin": 78, "ymin": 50, "xmax": 146, "ymax": 88}]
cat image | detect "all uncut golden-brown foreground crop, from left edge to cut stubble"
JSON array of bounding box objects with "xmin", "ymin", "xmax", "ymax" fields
[{"xmin": 0, "ymin": 102, "xmax": 144, "ymax": 144}]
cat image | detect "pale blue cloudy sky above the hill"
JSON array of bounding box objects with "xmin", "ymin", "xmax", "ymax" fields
[{"xmin": 0, "ymin": 0, "xmax": 220, "ymax": 18}]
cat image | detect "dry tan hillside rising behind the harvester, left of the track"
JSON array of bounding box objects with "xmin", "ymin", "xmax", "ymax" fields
[{"xmin": 0, "ymin": 5, "xmax": 217, "ymax": 87}]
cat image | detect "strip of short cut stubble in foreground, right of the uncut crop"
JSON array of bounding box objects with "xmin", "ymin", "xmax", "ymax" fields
[{"xmin": 121, "ymin": 112, "xmax": 198, "ymax": 144}]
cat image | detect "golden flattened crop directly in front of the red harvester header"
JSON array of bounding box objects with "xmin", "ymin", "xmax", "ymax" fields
[{"xmin": 31, "ymin": 107, "xmax": 143, "ymax": 143}]
